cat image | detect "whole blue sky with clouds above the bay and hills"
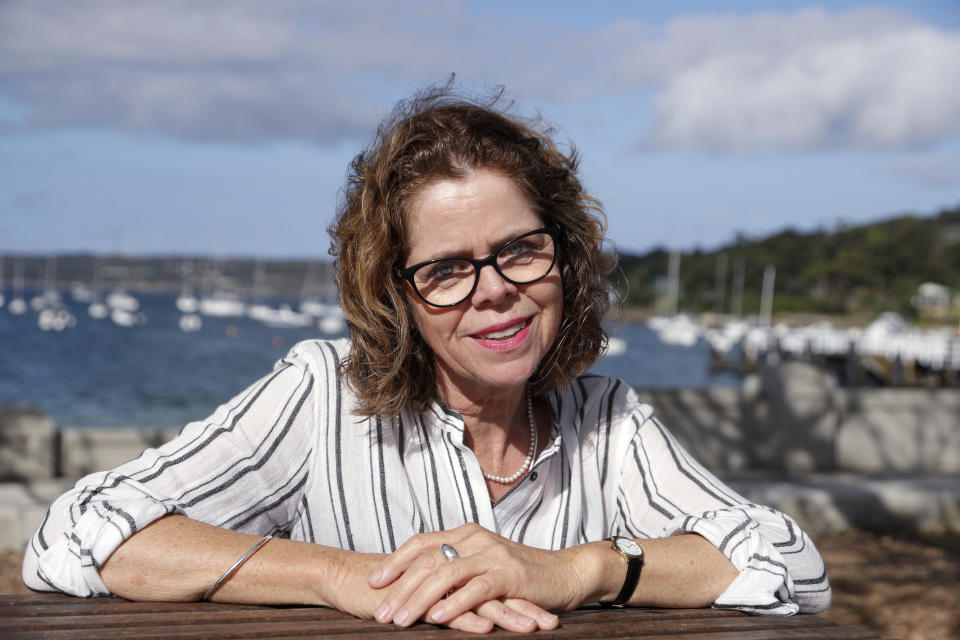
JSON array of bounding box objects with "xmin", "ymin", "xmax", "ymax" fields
[{"xmin": 0, "ymin": 0, "xmax": 960, "ymax": 258}]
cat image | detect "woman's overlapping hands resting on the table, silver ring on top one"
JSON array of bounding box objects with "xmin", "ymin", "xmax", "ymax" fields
[{"xmin": 369, "ymin": 524, "xmax": 588, "ymax": 631}]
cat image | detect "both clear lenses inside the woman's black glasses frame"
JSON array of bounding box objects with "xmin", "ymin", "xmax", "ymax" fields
[{"xmin": 413, "ymin": 233, "xmax": 555, "ymax": 306}]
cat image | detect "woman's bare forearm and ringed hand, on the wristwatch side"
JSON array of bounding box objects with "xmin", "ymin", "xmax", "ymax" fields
[{"xmin": 370, "ymin": 524, "xmax": 737, "ymax": 626}]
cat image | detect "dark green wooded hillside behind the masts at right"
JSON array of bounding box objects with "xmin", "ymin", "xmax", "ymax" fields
[{"xmin": 619, "ymin": 206, "xmax": 960, "ymax": 316}]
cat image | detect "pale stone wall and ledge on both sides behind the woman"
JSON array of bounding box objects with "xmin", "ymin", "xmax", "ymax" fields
[{"xmin": 0, "ymin": 363, "xmax": 960, "ymax": 549}]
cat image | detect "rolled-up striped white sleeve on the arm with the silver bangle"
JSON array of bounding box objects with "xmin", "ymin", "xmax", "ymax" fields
[{"xmin": 23, "ymin": 356, "xmax": 316, "ymax": 597}]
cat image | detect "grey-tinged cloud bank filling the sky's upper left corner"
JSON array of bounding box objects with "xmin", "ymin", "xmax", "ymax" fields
[{"xmin": 0, "ymin": 0, "xmax": 540, "ymax": 143}]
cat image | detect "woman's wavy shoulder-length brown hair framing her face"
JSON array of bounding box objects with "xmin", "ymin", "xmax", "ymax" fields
[{"xmin": 328, "ymin": 82, "xmax": 613, "ymax": 415}]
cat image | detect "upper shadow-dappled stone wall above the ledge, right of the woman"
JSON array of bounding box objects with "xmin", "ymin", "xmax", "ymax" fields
[{"xmin": 639, "ymin": 363, "xmax": 960, "ymax": 474}]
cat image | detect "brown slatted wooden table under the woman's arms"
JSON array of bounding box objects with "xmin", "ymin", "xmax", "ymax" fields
[{"xmin": 0, "ymin": 594, "xmax": 879, "ymax": 640}]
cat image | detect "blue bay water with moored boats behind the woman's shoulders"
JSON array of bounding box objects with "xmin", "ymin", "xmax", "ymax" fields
[{"xmin": 0, "ymin": 292, "xmax": 739, "ymax": 427}]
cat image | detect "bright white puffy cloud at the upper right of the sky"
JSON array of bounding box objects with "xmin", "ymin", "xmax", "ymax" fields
[{"xmin": 619, "ymin": 9, "xmax": 960, "ymax": 150}]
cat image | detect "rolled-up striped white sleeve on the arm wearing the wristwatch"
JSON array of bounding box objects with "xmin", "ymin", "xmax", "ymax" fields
[{"xmin": 618, "ymin": 400, "xmax": 831, "ymax": 615}]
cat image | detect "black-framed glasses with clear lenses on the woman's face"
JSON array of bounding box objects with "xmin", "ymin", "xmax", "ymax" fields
[{"xmin": 396, "ymin": 227, "xmax": 559, "ymax": 307}]
